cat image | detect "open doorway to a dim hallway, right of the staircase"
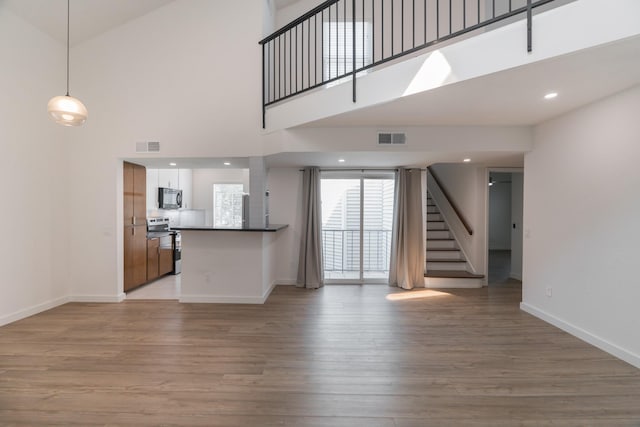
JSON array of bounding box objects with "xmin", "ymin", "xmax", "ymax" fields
[{"xmin": 487, "ymin": 170, "xmax": 524, "ymax": 286}]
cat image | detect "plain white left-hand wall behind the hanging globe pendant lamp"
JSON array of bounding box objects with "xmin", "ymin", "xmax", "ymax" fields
[{"xmin": 0, "ymin": 8, "xmax": 71, "ymax": 325}]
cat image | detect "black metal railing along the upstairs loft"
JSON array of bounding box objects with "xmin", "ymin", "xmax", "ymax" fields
[{"xmin": 260, "ymin": 0, "xmax": 554, "ymax": 127}]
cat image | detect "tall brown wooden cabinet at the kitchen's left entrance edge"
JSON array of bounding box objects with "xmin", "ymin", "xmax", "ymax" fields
[{"xmin": 123, "ymin": 162, "xmax": 147, "ymax": 291}]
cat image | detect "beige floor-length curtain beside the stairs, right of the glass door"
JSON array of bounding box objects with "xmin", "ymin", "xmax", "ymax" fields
[{"xmin": 389, "ymin": 168, "xmax": 425, "ymax": 289}]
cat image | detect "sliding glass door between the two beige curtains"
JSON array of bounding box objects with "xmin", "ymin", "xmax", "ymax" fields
[{"xmin": 321, "ymin": 172, "xmax": 394, "ymax": 283}]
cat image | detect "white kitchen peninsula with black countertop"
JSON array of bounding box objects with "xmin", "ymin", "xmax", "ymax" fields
[{"xmin": 172, "ymin": 224, "xmax": 287, "ymax": 304}]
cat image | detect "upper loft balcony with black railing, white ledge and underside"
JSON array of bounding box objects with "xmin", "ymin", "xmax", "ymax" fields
[{"xmin": 260, "ymin": 0, "xmax": 640, "ymax": 131}]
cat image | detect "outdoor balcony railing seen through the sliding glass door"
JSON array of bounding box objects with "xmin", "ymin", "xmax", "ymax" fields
[{"xmin": 322, "ymin": 230, "xmax": 391, "ymax": 272}]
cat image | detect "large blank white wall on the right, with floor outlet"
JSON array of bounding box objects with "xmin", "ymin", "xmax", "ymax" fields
[{"xmin": 522, "ymin": 87, "xmax": 640, "ymax": 367}]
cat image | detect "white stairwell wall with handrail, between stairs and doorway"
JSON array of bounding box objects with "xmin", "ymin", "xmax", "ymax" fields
[{"xmin": 432, "ymin": 163, "xmax": 488, "ymax": 274}]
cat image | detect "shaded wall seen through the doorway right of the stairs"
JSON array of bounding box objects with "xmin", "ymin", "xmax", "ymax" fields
[{"xmin": 488, "ymin": 172, "xmax": 511, "ymax": 250}]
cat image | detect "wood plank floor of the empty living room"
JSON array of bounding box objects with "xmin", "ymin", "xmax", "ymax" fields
[{"xmin": 0, "ymin": 285, "xmax": 640, "ymax": 427}]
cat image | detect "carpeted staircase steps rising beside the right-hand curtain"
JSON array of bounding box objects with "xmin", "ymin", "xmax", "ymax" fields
[{"xmin": 424, "ymin": 192, "xmax": 484, "ymax": 288}]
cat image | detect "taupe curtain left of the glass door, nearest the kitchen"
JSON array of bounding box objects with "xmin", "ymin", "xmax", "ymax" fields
[{"xmin": 297, "ymin": 167, "xmax": 324, "ymax": 289}]
